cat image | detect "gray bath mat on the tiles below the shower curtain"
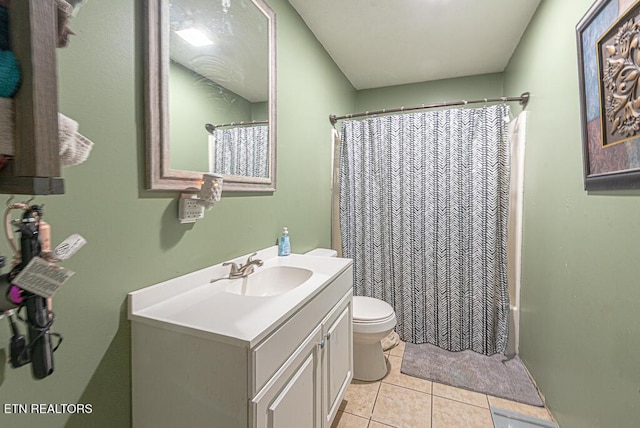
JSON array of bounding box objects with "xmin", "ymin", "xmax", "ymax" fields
[{"xmin": 400, "ymin": 343, "xmax": 544, "ymax": 407}]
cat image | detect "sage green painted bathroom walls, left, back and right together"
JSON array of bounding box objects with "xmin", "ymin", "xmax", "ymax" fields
[{"xmin": 0, "ymin": 0, "xmax": 640, "ymax": 428}]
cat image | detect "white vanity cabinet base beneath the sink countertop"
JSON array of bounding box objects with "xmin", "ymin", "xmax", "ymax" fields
[{"xmin": 130, "ymin": 254, "xmax": 353, "ymax": 428}]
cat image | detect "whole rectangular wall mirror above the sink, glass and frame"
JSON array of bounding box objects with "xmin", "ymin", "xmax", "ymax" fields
[{"xmin": 147, "ymin": 0, "xmax": 275, "ymax": 191}]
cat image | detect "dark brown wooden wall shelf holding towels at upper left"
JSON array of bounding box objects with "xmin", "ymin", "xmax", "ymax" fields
[{"xmin": 0, "ymin": 0, "xmax": 64, "ymax": 195}]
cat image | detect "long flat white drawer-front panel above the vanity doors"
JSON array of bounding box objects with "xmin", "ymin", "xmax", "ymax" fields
[{"xmin": 249, "ymin": 267, "xmax": 353, "ymax": 397}]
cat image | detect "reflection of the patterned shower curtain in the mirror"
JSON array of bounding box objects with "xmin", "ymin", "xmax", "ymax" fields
[{"xmin": 209, "ymin": 125, "xmax": 269, "ymax": 177}]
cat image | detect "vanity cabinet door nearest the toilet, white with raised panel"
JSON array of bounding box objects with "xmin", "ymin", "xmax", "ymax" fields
[{"xmin": 323, "ymin": 291, "xmax": 353, "ymax": 427}]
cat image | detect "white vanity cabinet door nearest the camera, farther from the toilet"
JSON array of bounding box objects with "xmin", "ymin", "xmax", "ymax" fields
[{"xmin": 251, "ymin": 326, "xmax": 326, "ymax": 428}]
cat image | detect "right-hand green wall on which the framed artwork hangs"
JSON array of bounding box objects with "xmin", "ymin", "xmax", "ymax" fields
[{"xmin": 505, "ymin": 0, "xmax": 640, "ymax": 428}]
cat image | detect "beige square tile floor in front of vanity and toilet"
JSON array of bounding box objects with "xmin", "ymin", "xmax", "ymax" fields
[{"xmin": 332, "ymin": 342, "xmax": 553, "ymax": 428}]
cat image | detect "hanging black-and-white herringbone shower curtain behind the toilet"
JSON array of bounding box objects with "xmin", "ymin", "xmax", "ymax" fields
[{"xmin": 339, "ymin": 105, "xmax": 509, "ymax": 355}]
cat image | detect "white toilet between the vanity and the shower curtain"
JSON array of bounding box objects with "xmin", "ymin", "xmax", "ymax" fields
[{"xmin": 307, "ymin": 248, "xmax": 396, "ymax": 381}]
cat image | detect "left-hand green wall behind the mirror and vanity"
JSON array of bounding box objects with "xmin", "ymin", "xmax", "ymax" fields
[{"xmin": 0, "ymin": 0, "xmax": 355, "ymax": 427}]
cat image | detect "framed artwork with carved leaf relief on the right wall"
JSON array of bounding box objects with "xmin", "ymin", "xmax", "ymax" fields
[{"xmin": 576, "ymin": 0, "xmax": 640, "ymax": 191}]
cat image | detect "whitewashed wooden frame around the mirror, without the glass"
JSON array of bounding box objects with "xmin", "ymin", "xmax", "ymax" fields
[{"xmin": 143, "ymin": 0, "xmax": 277, "ymax": 192}]
